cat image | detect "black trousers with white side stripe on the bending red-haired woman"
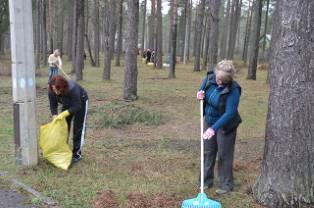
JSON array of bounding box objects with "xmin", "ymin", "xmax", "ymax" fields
[{"xmin": 67, "ymin": 100, "xmax": 88, "ymax": 157}]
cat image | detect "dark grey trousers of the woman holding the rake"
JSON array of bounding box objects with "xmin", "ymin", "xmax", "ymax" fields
[{"xmin": 204, "ymin": 121, "xmax": 237, "ymax": 191}]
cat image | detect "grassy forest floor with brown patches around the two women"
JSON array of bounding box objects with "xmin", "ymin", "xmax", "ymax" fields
[{"xmin": 0, "ymin": 56, "xmax": 269, "ymax": 208}]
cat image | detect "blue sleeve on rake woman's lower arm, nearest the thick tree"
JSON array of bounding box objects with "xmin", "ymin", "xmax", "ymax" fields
[{"xmin": 212, "ymin": 88, "xmax": 240, "ymax": 132}]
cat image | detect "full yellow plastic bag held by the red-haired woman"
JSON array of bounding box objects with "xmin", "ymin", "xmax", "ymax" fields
[{"xmin": 39, "ymin": 119, "xmax": 72, "ymax": 170}]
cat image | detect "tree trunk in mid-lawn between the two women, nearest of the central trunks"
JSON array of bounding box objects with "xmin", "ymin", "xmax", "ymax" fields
[{"xmin": 123, "ymin": 0, "xmax": 139, "ymax": 100}]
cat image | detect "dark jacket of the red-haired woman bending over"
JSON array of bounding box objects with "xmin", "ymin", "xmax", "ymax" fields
[{"xmin": 48, "ymin": 80, "xmax": 88, "ymax": 115}]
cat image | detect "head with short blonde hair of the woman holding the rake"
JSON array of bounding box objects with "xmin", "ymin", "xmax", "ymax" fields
[{"xmin": 215, "ymin": 60, "xmax": 236, "ymax": 84}]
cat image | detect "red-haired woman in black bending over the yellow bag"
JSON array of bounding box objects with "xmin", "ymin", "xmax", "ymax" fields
[{"xmin": 48, "ymin": 75, "xmax": 88, "ymax": 163}]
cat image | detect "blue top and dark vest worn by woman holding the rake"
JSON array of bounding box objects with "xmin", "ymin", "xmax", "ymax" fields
[{"xmin": 200, "ymin": 72, "xmax": 242, "ymax": 133}]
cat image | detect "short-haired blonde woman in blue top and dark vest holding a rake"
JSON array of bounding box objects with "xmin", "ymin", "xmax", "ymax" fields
[{"xmin": 197, "ymin": 60, "xmax": 241, "ymax": 194}]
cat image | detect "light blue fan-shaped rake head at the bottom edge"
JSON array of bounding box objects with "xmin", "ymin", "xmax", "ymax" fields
[{"xmin": 181, "ymin": 193, "xmax": 222, "ymax": 208}]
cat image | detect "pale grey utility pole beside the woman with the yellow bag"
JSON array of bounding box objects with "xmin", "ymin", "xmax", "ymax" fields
[{"xmin": 9, "ymin": 0, "xmax": 38, "ymax": 166}]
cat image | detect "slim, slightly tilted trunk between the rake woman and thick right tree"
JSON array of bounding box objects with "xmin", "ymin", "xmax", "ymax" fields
[{"xmin": 247, "ymin": 0, "xmax": 263, "ymax": 80}]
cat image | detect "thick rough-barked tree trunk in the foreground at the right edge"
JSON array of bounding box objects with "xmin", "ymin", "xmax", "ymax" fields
[{"xmin": 253, "ymin": 0, "xmax": 314, "ymax": 208}]
